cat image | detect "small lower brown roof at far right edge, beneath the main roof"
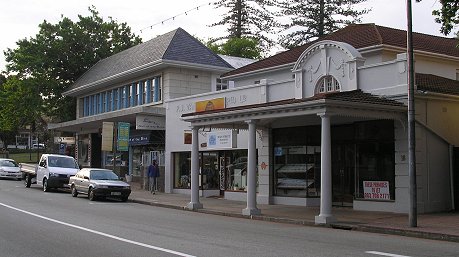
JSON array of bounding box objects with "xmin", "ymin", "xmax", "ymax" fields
[{"xmin": 415, "ymin": 73, "xmax": 459, "ymax": 95}]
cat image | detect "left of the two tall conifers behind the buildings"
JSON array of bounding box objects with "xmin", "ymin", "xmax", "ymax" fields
[{"xmin": 210, "ymin": 0, "xmax": 278, "ymax": 50}]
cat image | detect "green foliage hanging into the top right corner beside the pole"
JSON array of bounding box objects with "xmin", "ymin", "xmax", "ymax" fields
[{"xmin": 416, "ymin": 0, "xmax": 459, "ymax": 35}]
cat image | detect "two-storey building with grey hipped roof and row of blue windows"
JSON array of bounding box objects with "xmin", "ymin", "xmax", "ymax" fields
[{"xmin": 48, "ymin": 28, "xmax": 246, "ymax": 183}]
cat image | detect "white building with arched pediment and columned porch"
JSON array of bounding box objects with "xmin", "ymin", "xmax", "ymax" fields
[{"xmin": 165, "ymin": 24, "xmax": 459, "ymax": 223}]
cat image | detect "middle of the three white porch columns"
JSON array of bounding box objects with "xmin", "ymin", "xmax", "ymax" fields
[{"xmin": 242, "ymin": 120, "xmax": 261, "ymax": 216}]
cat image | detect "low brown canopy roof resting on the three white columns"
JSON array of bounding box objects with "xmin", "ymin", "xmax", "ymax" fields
[{"xmin": 182, "ymin": 89, "xmax": 404, "ymax": 117}]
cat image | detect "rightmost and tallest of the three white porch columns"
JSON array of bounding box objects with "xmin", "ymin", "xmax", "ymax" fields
[{"xmin": 315, "ymin": 113, "xmax": 335, "ymax": 224}]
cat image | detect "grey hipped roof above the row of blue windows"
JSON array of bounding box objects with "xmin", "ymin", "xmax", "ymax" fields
[{"xmin": 68, "ymin": 28, "xmax": 233, "ymax": 91}]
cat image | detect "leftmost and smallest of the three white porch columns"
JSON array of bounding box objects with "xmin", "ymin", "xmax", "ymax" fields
[{"xmin": 187, "ymin": 127, "xmax": 202, "ymax": 210}]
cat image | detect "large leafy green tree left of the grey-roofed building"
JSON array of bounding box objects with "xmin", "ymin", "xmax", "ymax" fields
[{"xmin": 0, "ymin": 6, "xmax": 141, "ymax": 123}]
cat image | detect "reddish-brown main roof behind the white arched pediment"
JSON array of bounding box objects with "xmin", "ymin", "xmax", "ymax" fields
[{"xmin": 224, "ymin": 23, "xmax": 459, "ymax": 77}]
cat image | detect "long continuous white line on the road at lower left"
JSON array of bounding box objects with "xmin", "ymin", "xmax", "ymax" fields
[{"xmin": 0, "ymin": 203, "xmax": 196, "ymax": 257}]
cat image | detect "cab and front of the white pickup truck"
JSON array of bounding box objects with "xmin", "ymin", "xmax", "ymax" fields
[{"xmin": 35, "ymin": 154, "xmax": 80, "ymax": 192}]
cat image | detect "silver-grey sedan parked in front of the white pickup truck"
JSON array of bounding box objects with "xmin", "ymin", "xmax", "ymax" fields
[{"xmin": 69, "ymin": 168, "xmax": 131, "ymax": 202}]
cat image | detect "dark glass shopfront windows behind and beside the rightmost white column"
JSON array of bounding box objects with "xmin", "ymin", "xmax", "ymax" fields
[{"xmin": 272, "ymin": 120, "xmax": 395, "ymax": 206}]
